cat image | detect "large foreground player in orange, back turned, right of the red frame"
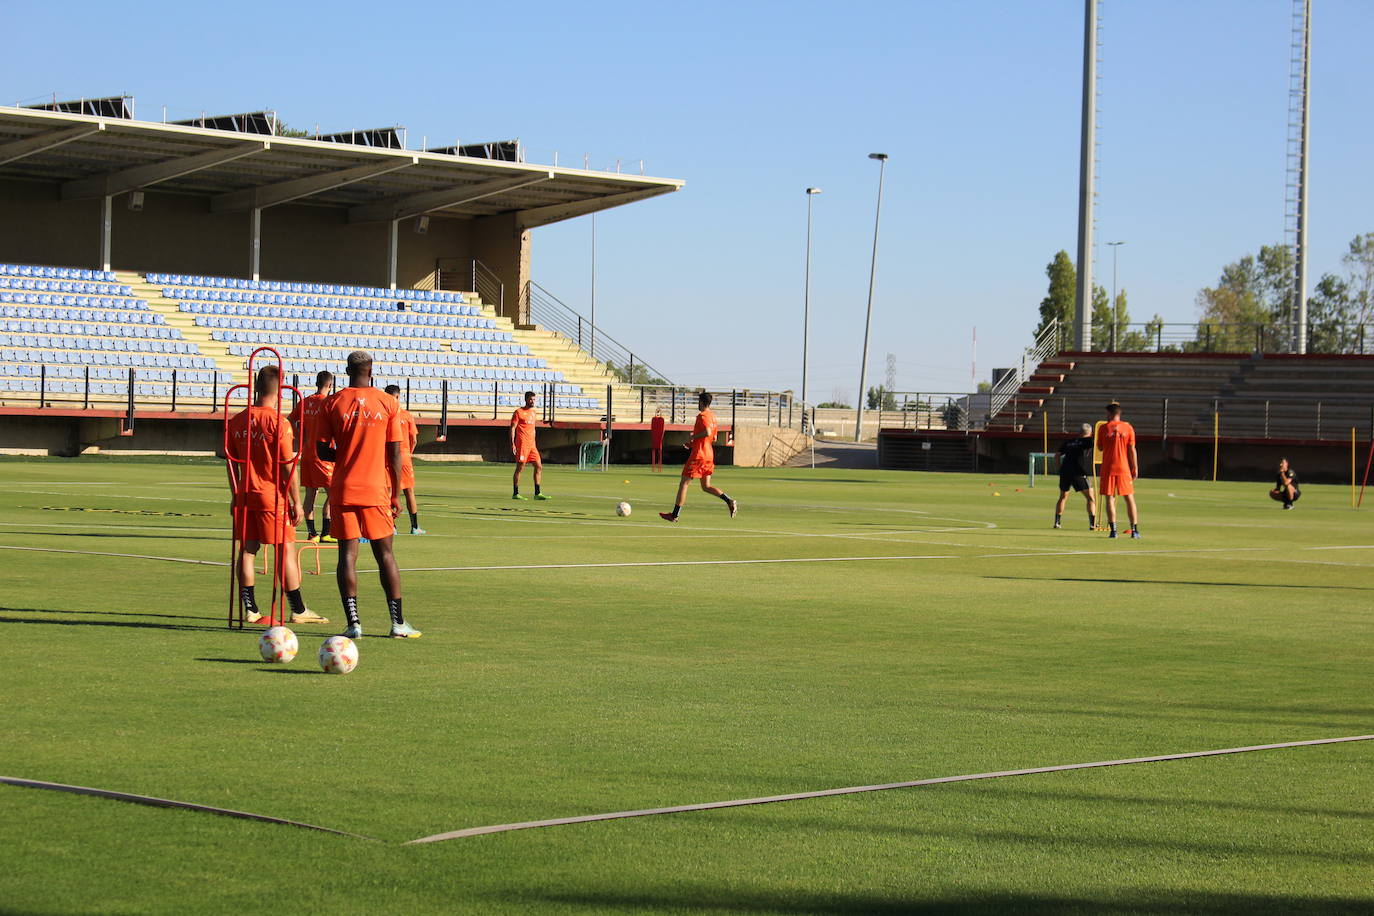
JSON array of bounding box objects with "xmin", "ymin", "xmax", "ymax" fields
[{"xmin": 315, "ymin": 350, "xmax": 420, "ymax": 639}]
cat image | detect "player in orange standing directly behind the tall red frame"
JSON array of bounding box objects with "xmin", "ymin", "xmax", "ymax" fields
[{"xmin": 227, "ymin": 365, "xmax": 328, "ymax": 626}]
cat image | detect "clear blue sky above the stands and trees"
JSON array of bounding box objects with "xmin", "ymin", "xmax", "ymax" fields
[{"xmin": 0, "ymin": 0, "xmax": 1374, "ymax": 400}]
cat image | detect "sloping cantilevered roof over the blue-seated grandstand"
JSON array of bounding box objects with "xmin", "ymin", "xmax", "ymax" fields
[{"xmin": 0, "ymin": 106, "xmax": 683, "ymax": 228}]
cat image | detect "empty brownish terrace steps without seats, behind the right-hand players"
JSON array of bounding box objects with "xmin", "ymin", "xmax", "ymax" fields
[{"xmin": 988, "ymin": 353, "xmax": 1374, "ymax": 439}]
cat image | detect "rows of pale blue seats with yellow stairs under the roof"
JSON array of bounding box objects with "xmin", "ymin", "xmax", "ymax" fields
[{"xmin": 0, "ymin": 264, "xmax": 613, "ymax": 417}]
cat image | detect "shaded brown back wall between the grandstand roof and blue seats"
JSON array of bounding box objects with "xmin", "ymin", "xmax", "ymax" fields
[{"xmin": 0, "ymin": 181, "xmax": 505, "ymax": 289}]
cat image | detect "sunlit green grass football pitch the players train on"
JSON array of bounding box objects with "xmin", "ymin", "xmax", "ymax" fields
[{"xmin": 0, "ymin": 459, "xmax": 1374, "ymax": 915}]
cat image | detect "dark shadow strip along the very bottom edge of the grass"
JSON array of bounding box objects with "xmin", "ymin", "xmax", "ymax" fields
[{"xmin": 521, "ymin": 884, "xmax": 1374, "ymax": 916}]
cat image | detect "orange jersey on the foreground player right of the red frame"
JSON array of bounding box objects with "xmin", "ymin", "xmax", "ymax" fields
[{"xmin": 316, "ymin": 387, "xmax": 404, "ymax": 507}]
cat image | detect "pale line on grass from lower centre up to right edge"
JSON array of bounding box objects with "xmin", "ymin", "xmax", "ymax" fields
[{"xmin": 405, "ymin": 735, "xmax": 1374, "ymax": 846}]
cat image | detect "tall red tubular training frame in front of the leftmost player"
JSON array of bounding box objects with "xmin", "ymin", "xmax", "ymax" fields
[{"xmin": 223, "ymin": 346, "xmax": 301, "ymax": 629}]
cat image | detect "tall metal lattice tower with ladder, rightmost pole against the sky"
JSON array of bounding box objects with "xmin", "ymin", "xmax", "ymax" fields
[{"xmin": 1283, "ymin": 0, "xmax": 1312, "ymax": 353}]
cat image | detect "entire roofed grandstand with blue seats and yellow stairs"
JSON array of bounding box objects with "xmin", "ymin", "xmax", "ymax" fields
[{"xmin": 0, "ymin": 96, "xmax": 824, "ymax": 460}]
